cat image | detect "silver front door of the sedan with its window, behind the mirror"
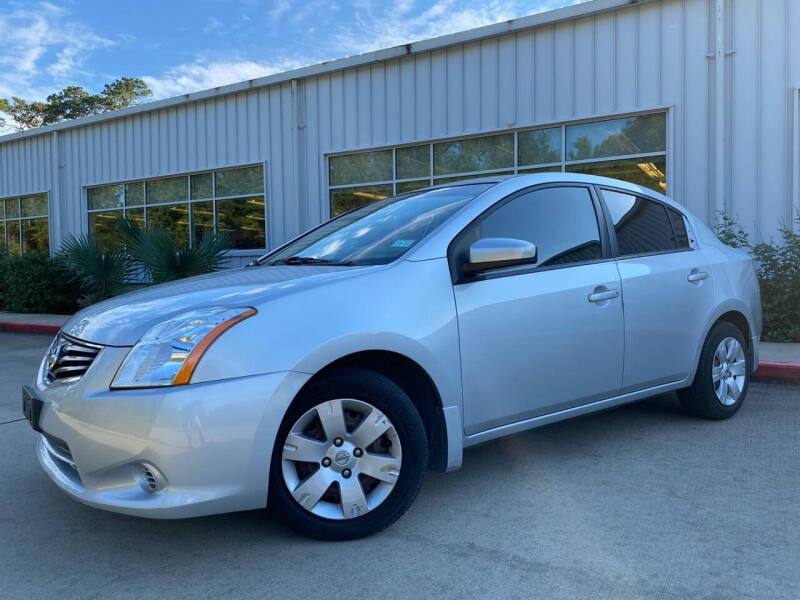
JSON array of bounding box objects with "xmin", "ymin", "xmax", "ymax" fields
[{"xmin": 451, "ymin": 186, "xmax": 624, "ymax": 435}]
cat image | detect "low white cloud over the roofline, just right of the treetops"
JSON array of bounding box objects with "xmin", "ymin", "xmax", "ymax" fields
[{"xmin": 142, "ymin": 58, "xmax": 308, "ymax": 98}]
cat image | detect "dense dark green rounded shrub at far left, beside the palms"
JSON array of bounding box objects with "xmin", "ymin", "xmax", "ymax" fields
[{"xmin": 0, "ymin": 254, "xmax": 80, "ymax": 314}]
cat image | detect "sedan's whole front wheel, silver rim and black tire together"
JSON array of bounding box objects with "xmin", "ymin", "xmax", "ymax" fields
[{"xmin": 270, "ymin": 369, "xmax": 428, "ymax": 540}]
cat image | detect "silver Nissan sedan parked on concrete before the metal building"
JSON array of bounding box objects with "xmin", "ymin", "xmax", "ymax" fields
[{"xmin": 23, "ymin": 173, "xmax": 761, "ymax": 539}]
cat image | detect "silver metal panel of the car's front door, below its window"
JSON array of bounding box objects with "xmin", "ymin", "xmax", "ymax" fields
[{"xmin": 455, "ymin": 261, "xmax": 623, "ymax": 435}]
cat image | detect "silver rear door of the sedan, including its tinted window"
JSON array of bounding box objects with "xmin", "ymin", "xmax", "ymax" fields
[{"xmin": 601, "ymin": 188, "xmax": 714, "ymax": 393}]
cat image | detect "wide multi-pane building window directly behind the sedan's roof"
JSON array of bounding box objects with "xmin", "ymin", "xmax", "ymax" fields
[{"xmin": 328, "ymin": 112, "xmax": 667, "ymax": 216}]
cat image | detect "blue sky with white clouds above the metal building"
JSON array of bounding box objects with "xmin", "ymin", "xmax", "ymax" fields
[{"xmin": 0, "ymin": 0, "xmax": 580, "ymax": 129}]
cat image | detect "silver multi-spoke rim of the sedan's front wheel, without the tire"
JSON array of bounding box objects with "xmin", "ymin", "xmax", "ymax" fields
[{"xmin": 281, "ymin": 398, "xmax": 402, "ymax": 519}]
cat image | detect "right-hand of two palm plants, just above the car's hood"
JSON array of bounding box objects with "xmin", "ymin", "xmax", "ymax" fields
[{"xmin": 118, "ymin": 218, "xmax": 231, "ymax": 283}]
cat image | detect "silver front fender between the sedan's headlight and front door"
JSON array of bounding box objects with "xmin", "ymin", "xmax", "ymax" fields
[{"xmin": 192, "ymin": 258, "xmax": 461, "ymax": 407}]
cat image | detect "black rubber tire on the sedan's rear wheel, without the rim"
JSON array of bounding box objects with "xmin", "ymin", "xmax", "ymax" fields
[{"xmin": 678, "ymin": 321, "xmax": 753, "ymax": 420}]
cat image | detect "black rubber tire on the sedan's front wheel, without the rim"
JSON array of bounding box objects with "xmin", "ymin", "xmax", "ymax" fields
[{"xmin": 268, "ymin": 368, "xmax": 428, "ymax": 540}]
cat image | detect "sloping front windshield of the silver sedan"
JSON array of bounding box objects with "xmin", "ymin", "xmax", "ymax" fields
[{"xmin": 259, "ymin": 183, "xmax": 493, "ymax": 265}]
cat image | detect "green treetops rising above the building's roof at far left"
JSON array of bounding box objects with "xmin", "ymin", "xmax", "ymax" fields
[{"xmin": 0, "ymin": 77, "xmax": 153, "ymax": 131}]
